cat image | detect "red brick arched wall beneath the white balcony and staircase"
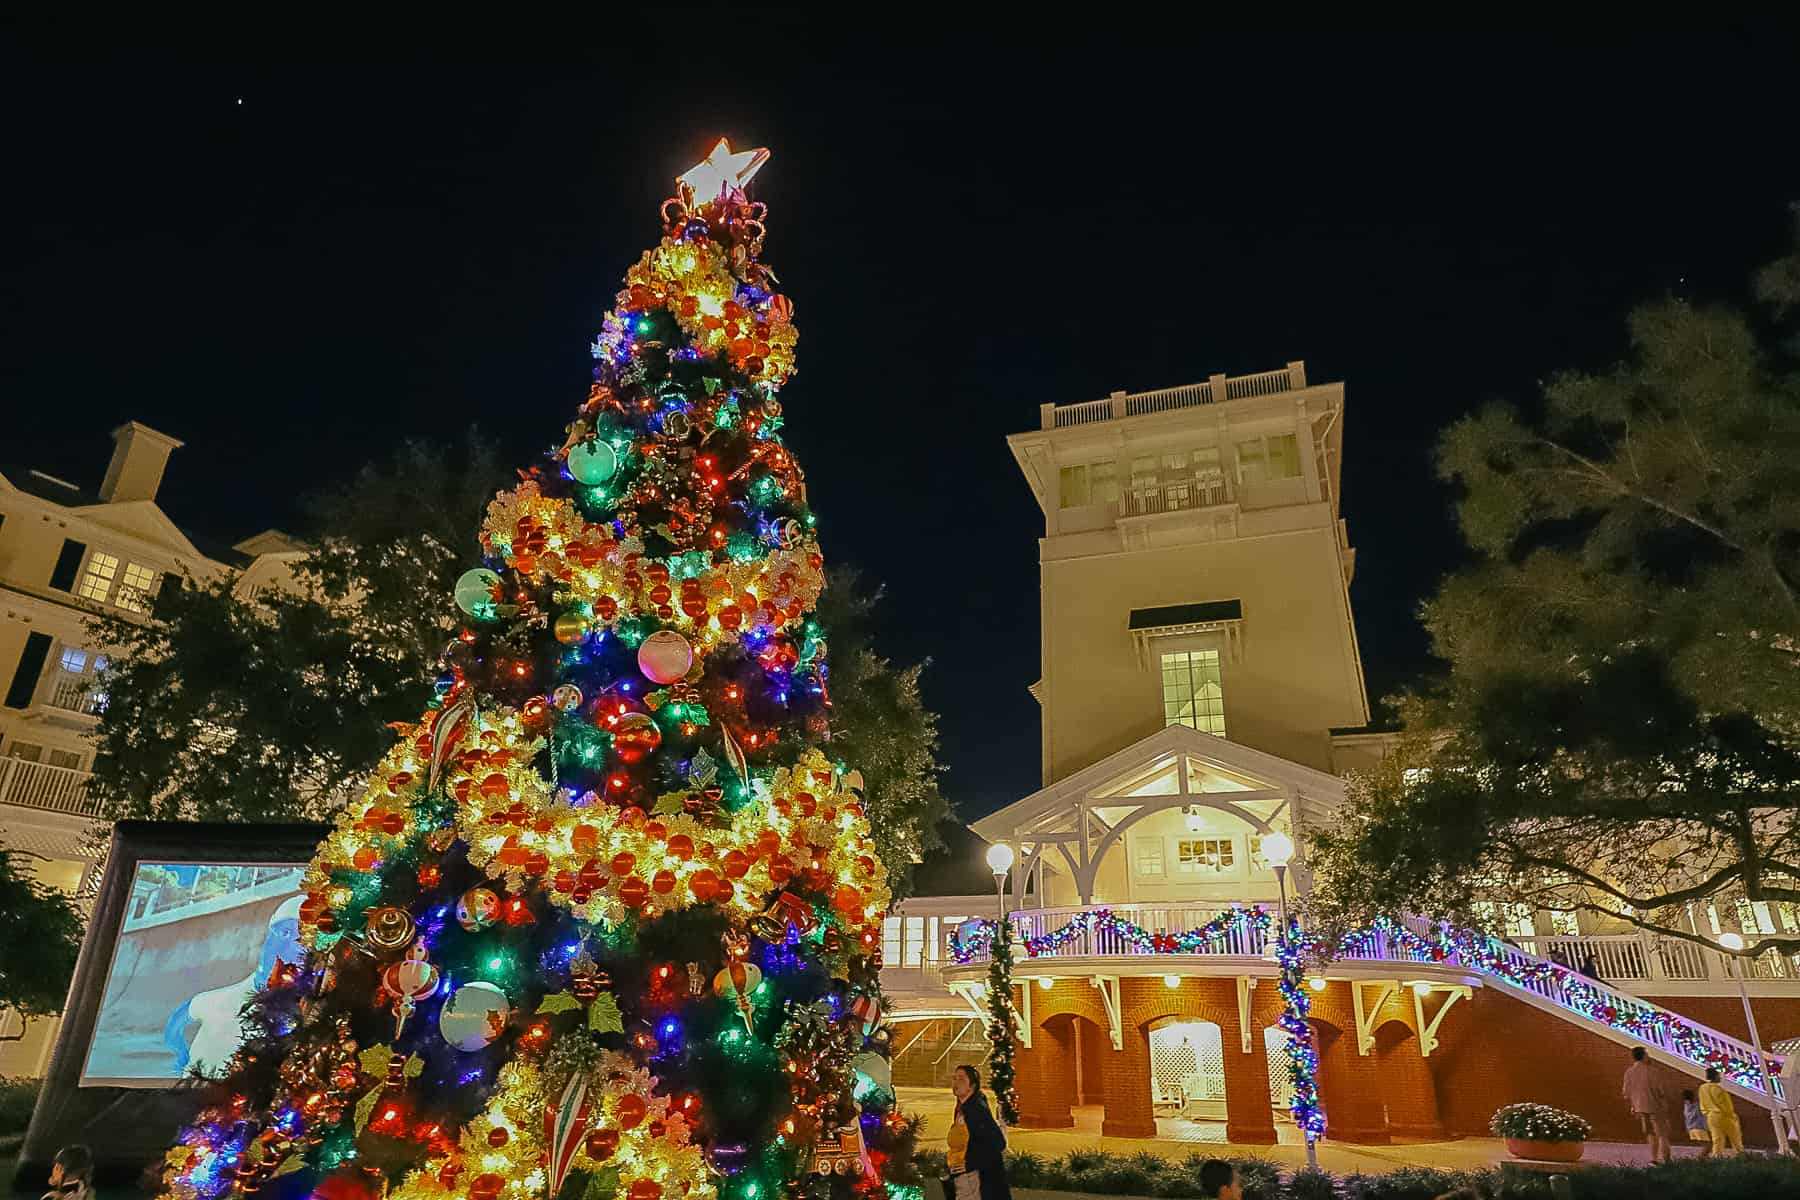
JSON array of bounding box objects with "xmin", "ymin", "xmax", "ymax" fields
[{"xmin": 1019, "ymin": 977, "xmax": 1778, "ymax": 1144}]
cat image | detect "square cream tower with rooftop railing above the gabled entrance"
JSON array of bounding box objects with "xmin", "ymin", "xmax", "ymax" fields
[{"xmin": 1006, "ymin": 362, "xmax": 1368, "ymax": 784}]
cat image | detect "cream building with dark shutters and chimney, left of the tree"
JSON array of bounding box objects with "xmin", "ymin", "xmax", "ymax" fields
[{"xmin": 0, "ymin": 421, "xmax": 302, "ymax": 1076}]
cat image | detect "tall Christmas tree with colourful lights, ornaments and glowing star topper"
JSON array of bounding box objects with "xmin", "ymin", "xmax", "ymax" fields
[{"xmin": 164, "ymin": 142, "xmax": 918, "ymax": 1200}]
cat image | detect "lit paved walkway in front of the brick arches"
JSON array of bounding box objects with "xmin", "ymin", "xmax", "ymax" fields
[{"xmin": 898, "ymin": 1087, "xmax": 1697, "ymax": 1175}]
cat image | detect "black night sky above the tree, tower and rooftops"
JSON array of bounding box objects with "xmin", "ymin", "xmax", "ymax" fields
[{"xmin": 0, "ymin": 39, "xmax": 1800, "ymax": 817}]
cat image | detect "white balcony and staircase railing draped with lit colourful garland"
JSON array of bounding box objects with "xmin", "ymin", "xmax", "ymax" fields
[{"xmin": 950, "ymin": 907, "xmax": 1784, "ymax": 1119}]
